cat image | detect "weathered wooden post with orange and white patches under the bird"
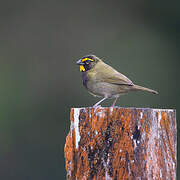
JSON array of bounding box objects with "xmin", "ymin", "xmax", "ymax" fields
[{"xmin": 64, "ymin": 107, "xmax": 177, "ymax": 180}]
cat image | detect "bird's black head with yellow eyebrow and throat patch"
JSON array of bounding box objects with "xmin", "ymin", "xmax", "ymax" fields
[{"xmin": 76, "ymin": 55, "xmax": 101, "ymax": 72}]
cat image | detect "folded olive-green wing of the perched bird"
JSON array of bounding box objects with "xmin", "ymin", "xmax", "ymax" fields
[{"xmin": 96, "ymin": 62, "xmax": 134, "ymax": 86}]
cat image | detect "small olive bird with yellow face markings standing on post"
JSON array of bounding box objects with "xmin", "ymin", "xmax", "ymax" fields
[{"xmin": 77, "ymin": 55, "xmax": 158, "ymax": 107}]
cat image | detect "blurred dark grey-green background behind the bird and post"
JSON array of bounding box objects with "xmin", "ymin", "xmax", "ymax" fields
[{"xmin": 0, "ymin": 0, "xmax": 180, "ymax": 180}]
